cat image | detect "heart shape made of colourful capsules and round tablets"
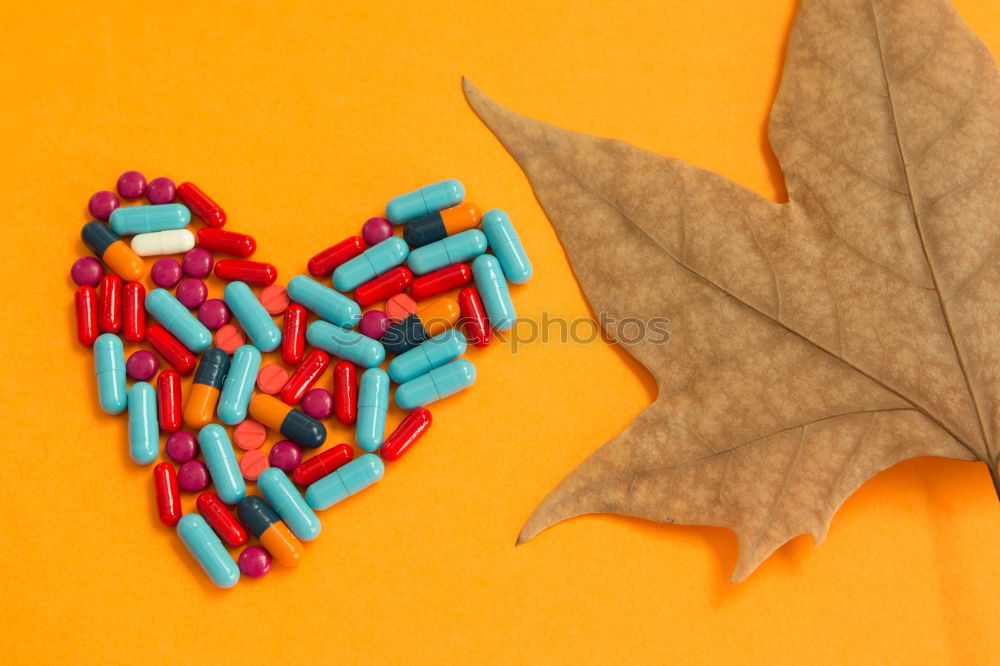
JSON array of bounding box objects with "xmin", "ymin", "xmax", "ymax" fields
[{"xmin": 71, "ymin": 171, "xmax": 532, "ymax": 588}]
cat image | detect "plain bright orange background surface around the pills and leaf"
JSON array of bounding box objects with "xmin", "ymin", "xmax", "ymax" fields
[{"xmin": 0, "ymin": 0, "xmax": 1000, "ymax": 664}]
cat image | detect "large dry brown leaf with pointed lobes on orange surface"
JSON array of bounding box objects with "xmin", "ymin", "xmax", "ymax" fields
[{"xmin": 464, "ymin": 0, "xmax": 1000, "ymax": 581}]
